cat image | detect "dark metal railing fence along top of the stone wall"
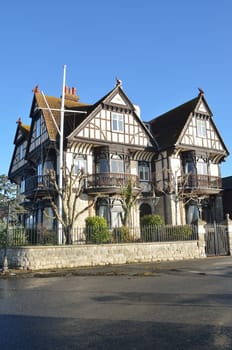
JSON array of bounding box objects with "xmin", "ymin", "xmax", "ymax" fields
[{"xmin": 0, "ymin": 225, "xmax": 198, "ymax": 247}]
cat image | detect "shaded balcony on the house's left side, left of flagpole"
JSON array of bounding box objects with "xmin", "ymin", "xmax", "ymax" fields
[{"xmin": 23, "ymin": 175, "xmax": 54, "ymax": 198}]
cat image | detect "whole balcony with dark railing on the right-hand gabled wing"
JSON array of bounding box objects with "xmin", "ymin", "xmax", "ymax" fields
[{"xmin": 179, "ymin": 174, "xmax": 222, "ymax": 194}]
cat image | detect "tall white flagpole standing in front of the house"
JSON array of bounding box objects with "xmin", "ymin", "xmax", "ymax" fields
[{"xmin": 58, "ymin": 65, "xmax": 66, "ymax": 244}]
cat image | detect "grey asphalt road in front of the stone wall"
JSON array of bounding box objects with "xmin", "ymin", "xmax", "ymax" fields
[{"xmin": 0, "ymin": 257, "xmax": 232, "ymax": 350}]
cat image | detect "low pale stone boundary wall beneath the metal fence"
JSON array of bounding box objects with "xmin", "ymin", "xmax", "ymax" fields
[{"xmin": 0, "ymin": 241, "xmax": 206, "ymax": 270}]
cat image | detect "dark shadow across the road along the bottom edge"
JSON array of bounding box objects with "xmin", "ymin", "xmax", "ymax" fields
[{"xmin": 0, "ymin": 315, "xmax": 232, "ymax": 350}]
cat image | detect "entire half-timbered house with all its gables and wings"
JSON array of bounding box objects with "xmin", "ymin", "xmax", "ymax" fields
[{"xmin": 8, "ymin": 81, "xmax": 229, "ymax": 242}]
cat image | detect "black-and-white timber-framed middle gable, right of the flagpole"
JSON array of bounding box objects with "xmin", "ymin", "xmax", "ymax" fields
[{"xmin": 68, "ymin": 87, "xmax": 152, "ymax": 149}]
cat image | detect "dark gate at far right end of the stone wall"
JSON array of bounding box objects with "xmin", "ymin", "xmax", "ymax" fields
[{"xmin": 205, "ymin": 223, "xmax": 230, "ymax": 256}]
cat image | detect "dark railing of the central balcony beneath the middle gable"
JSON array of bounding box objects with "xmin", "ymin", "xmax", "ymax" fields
[{"xmin": 86, "ymin": 173, "xmax": 139, "ymax": 189}]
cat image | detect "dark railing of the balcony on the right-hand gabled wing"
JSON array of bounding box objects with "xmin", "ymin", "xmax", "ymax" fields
[{"xmin": 180, "ymin": 174, "xmax": 222, "ymax": 189}]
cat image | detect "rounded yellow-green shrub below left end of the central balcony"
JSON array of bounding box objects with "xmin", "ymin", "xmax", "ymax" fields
[{"xmin": 85, "ymin": 216, "xmax": 110, "ymax": 243}]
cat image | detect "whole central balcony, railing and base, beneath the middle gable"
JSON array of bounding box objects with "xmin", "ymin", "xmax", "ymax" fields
[{"xmin": 86, "ymin": 173, "xmax": 140, "ymax": 193}]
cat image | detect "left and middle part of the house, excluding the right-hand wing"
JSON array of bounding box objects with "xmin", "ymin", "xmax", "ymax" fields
[{"xmin": 8, "ymin": 81, "xmax": 157, "ymax": 241}]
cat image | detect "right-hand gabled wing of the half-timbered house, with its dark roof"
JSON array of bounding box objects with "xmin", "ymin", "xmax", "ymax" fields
[{"xmin": 149, "ymin": 90, "xmax": 229, "ymax": 224}]
